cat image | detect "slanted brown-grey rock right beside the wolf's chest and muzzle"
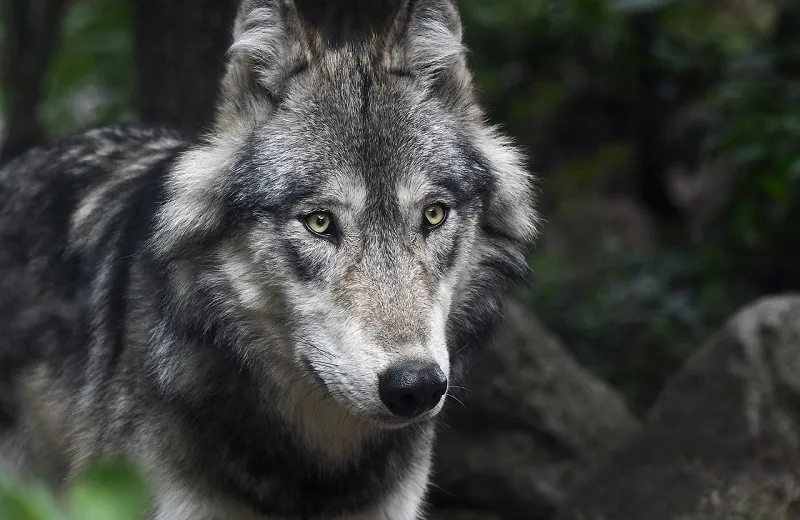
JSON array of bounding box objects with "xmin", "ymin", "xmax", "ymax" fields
[{"xmin": 433, "ymin": 303, "xmax": 638, "ymax": 520}]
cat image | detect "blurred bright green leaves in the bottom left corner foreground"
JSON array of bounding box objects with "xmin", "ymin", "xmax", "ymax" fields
[{"xmin": 0, "ymin": 460, "xmax": 148, "ymax": 520}]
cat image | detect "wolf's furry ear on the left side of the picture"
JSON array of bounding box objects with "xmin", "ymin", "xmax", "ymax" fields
[{"xmin": 212, "ymin": 0, "xmax": 312, "ymax": 134}]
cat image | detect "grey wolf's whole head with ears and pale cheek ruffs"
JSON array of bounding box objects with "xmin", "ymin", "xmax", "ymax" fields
[{"xmin": 151, "ymin": 0, "xmax": 537, "ymax": 427}]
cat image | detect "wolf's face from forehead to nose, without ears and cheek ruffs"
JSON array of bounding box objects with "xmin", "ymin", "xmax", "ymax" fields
[{"xmin": 219, "ymin": 60, "xmax": 491, "ymax": 424}]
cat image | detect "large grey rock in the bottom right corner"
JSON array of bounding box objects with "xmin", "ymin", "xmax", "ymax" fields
[{"xmin": 561, "ymin": 295, "xmax": 800, "ymax": 520}]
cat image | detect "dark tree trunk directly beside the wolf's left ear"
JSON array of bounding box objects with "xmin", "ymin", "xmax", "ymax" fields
[{"xmin": 132, "ymin": 0, "xmax": 239, "ymax": 133}]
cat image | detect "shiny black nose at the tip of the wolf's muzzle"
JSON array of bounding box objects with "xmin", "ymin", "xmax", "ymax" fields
[{"xmin": 378, "ymin": 362, "xmax": 447, "ymax": 418}]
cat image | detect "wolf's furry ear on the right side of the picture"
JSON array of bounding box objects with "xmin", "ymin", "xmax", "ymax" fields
[{"xmin": 385, "ymin": 0, "xmax": 474, "ymax": 110}]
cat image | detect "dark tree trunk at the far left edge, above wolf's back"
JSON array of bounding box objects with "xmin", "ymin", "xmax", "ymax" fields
[{"xmin": 0, "ymin": 0, "xmax": 66, "ymax": 163}]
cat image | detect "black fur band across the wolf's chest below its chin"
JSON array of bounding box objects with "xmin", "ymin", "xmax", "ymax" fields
[{"xmin": 162, "ymin": 359, "xmax": 421, "ymax": 518}]
